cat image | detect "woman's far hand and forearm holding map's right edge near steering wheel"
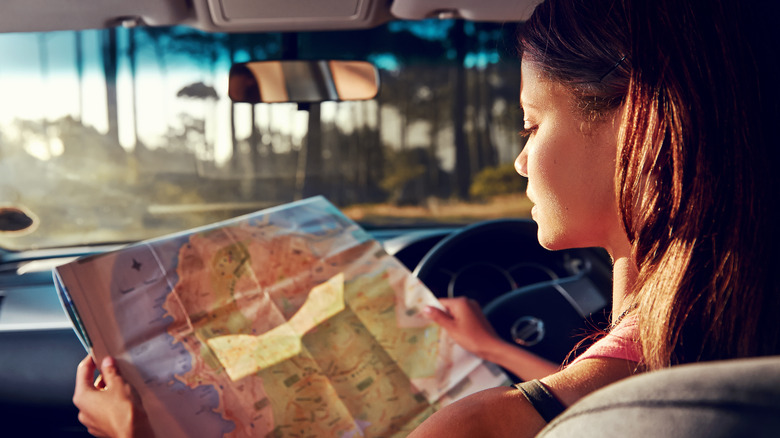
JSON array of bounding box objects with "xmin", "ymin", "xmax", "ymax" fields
[{"xmin": 424, "ymin": 297, "xmax": 560, "ymax": 380}]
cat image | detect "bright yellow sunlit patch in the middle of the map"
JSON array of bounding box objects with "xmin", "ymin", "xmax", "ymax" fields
[{"xmin": 206, "ymin": 273, "xmax": 344, "ymax": 381}]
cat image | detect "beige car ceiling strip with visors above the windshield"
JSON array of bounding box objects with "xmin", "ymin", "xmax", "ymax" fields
[{"xmin": 0, "ymin": 0, "xmax": 540, "ymax": 32}]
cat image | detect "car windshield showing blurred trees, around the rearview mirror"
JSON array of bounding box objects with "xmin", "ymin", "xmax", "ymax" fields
[{"xmin": 0, "ymin": 20, "xmax": 529, "ymax": 250}]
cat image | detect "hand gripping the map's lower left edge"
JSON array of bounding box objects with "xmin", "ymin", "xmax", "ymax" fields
[{"xmin": 73, "ymin": 356, "xmax": 154, "ymax": 438}]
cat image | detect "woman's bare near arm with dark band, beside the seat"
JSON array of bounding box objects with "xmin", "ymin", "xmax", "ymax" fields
[{"xmin": 409, "ymin": 358, "xmax": 637, "ymax": 438}]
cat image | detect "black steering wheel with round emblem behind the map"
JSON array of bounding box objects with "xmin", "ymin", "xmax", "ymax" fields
[{"xmin": 414, "ymin": 219, "xmax": 611, "ymax": 374}]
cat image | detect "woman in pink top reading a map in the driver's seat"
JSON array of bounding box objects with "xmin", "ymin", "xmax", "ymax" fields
[{"xmin": 74, "ymin": 0, "xmax": 780, "ymax": 437}]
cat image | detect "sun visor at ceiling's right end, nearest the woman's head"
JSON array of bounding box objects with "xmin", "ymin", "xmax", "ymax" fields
[{"xmin": 390, "ymin": 0, "xmax": 541, "ymax": 22}]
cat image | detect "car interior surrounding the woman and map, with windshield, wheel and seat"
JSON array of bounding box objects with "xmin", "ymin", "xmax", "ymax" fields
[{"xmin": 0, "ymin": 0, "xmax": 780, "ymax": 437}]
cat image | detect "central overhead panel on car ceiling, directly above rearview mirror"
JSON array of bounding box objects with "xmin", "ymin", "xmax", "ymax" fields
[{"xmin": 194, "ymin": 0, "xmax": 390, "ymax": 32}]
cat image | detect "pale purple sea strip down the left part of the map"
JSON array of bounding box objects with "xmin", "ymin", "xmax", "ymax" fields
[{"xmin": 112, "ymin": 236, "xmax": 235, "ymax": 436}]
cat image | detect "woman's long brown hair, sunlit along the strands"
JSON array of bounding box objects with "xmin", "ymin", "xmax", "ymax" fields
[{"xmin": 520, "ymin": 0, "xmax": 780, "ymax": 369}]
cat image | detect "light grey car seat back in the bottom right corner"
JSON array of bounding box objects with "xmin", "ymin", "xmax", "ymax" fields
[{"xmin": 537, "ymin": 356, "xmax": 780, "ymax": 438}]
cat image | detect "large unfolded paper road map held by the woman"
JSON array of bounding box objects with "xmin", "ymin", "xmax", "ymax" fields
[{"xmin": 55, "ymin": 197, "xmax": 508, "ymax": 437}]
